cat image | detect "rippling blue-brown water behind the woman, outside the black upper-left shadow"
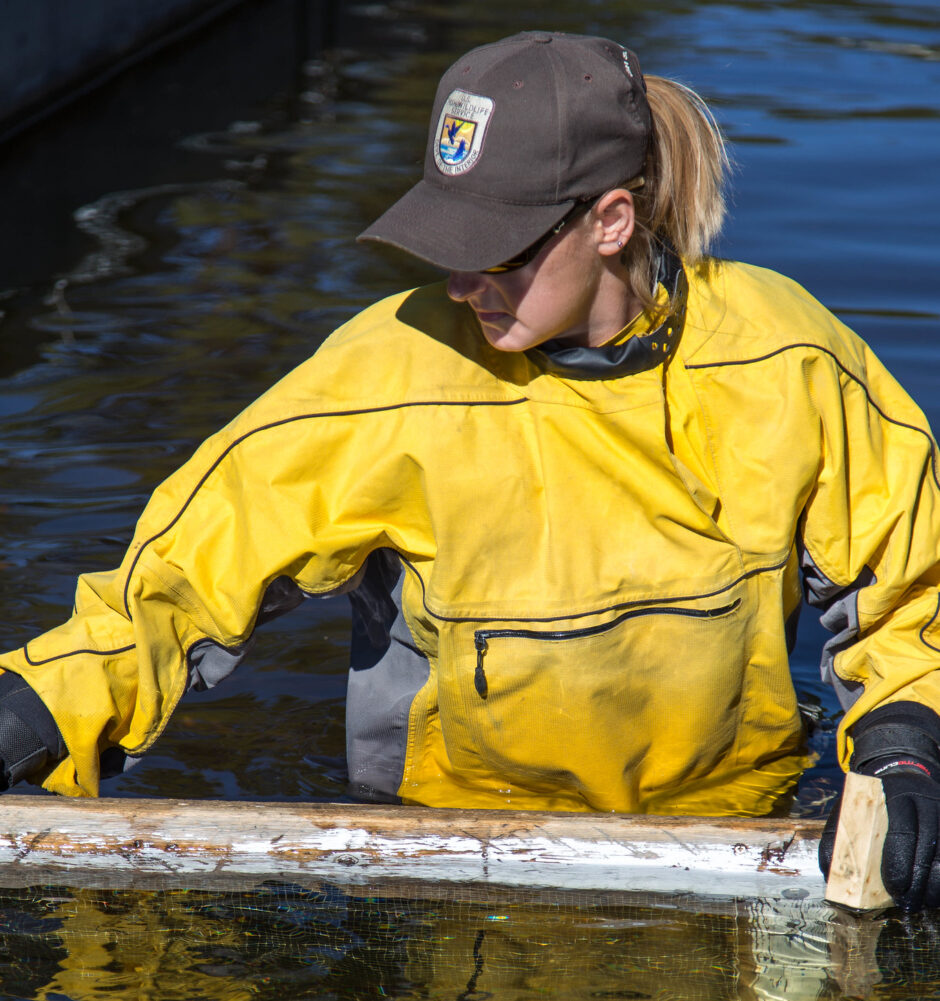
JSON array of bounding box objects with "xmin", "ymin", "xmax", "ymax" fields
[{"xmin": 0, "ymin": 2, "xmax": 940, "ymax": 796}]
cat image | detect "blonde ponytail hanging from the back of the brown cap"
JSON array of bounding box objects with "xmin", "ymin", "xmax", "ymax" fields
[{"xmin": 624, "ymin": 76, "xmax": 731, "ymax": 306}]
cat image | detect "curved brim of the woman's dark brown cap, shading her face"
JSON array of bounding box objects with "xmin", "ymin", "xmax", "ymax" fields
[{"xmin": 357, "ymin": 180, "xmax": 575, "ymax": 271}]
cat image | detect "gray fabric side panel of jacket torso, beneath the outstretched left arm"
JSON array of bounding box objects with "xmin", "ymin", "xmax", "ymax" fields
[{"xmin": 346, "ymin": 550, "xmax": 429, "ymax": 802}]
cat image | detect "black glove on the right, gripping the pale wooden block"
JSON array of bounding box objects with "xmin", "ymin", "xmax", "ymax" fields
[{"xmin": 819, "ymin": 702, "xmax": 940, "ymax": 911}]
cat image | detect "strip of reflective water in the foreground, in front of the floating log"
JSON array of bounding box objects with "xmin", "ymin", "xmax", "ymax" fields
[{"xmin": 0, "ymin": 882, "xmax": 940, "ymax": 1001}]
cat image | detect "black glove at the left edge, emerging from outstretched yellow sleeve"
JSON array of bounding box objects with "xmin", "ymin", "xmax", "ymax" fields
[{"xmin": 0, "ymin": 671, "xmax": 66, "ymax": 792}]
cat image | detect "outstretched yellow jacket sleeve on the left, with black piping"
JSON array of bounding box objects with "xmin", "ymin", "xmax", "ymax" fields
[{"xmin": 0, "ymin": 348, "xmax": 422, "ymax": 796}]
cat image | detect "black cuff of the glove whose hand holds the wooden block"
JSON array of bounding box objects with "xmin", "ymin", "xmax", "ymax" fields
[{"xmin": 850, "ymin": 702, "xmax": 940, "ymax": 782}]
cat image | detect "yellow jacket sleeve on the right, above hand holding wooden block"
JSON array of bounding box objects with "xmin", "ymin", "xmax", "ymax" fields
[{"xmin": 795, "ymin": 338, "xmax": 940, "ymax": 770}]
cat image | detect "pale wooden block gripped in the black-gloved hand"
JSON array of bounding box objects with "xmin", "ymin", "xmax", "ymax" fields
[{"xmin": 826, "ymin": 772, "xmax": 893, "ymax": 911}]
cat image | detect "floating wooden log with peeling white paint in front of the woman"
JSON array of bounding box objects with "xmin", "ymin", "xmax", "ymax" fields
[{"xmin": 0, "ymin": 796, "xmax": 825, "ymax": 903}]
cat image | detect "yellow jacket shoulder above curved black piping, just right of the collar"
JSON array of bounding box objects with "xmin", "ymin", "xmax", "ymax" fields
[{"xmin": 683, "ymin": 258, "xmax": 866, "ymax": 376}]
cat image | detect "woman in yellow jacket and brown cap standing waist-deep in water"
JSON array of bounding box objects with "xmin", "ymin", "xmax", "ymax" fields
[{"xmin": 0, "ymin": 32, "xmax": 940, "ymax": 907}]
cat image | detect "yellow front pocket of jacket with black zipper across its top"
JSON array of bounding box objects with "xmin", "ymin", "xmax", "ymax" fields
[{"xmin": 438, "ymin": 582, "xmax": 749, "ymax": 812}]
